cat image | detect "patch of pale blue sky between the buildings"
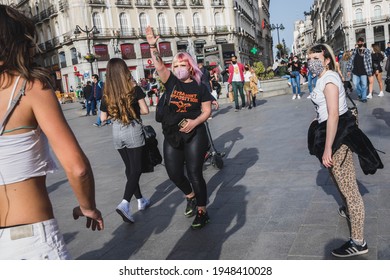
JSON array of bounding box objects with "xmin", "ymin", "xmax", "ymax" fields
[{"xmin": 269, "ymin": 0, "xmax": 314, "ymax": 53}]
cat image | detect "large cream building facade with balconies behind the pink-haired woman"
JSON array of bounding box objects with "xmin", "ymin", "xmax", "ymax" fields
[{"xmin": 0, "ymin": 0, "xmax": 272, "ymax": 91}]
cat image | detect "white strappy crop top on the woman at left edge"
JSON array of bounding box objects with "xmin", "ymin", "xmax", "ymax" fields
[{"xmin": 0, "ymin": 79, "xmax": 57, "ymax": 185}]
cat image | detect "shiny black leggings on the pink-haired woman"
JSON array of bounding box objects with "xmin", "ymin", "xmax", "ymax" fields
[{"xmin": 164, "ymin": 124, "xmax": 208, "ymax": 206}]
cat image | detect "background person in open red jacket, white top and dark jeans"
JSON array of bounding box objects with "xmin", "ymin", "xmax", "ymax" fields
[{"xmin": 228, "ymin": 55, "xmax": 245, "ymax": 112}]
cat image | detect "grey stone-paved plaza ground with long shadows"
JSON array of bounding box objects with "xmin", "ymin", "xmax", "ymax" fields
[{"xmin": 47, "ymin": 86, "xmax": 390, "ymax": 260}]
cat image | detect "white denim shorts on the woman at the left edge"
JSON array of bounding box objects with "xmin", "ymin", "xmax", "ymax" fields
[{"xmin": 0, "ymin": 219, "xmax": 71, "ymax": 260}]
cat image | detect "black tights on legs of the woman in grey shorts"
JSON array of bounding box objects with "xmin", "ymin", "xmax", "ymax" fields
[{"xmin": 118, "ymin": 147, "xmax": 143, "ymax": 201}]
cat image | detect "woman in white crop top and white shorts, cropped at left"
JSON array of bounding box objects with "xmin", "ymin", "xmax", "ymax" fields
[{"xmin": 0, "ymin": 5, "xmax": 104, "ymax": 259}]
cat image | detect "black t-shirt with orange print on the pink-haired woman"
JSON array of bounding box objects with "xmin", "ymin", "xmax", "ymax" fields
[{"xmin": 164, "ymin": 72, "xmax": 212, "ymax": 120}]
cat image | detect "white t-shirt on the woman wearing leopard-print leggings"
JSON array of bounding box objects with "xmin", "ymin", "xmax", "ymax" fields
[{"xmin": 311, "ymin": 71, "xmax": 348, "ymax": 123}]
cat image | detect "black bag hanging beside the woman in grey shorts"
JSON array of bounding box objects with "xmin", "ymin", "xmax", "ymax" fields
[{"xmin": 139, "ymin": 122, "xmax": 162, "ymax": 173}]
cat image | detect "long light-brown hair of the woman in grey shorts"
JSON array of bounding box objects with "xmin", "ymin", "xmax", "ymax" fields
[{"xmin": 103, "ymin": 58, "xmax": 137, "ymax": 124}]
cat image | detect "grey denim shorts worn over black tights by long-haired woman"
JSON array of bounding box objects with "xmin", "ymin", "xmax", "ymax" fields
[{"xmin": 112, "ymin": 121, "xmax": 145, "ymax": 150}]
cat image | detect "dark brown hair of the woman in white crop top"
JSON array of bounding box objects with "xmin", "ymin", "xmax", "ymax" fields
[{"xmin": 0, "ymin": 5, "xmax": 53, "ymax": 89}]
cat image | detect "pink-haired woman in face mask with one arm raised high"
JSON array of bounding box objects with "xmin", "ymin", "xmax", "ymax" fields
[{"xmin": 146, "ymin": 26, "xmax": 212, "ymax": 229}]
